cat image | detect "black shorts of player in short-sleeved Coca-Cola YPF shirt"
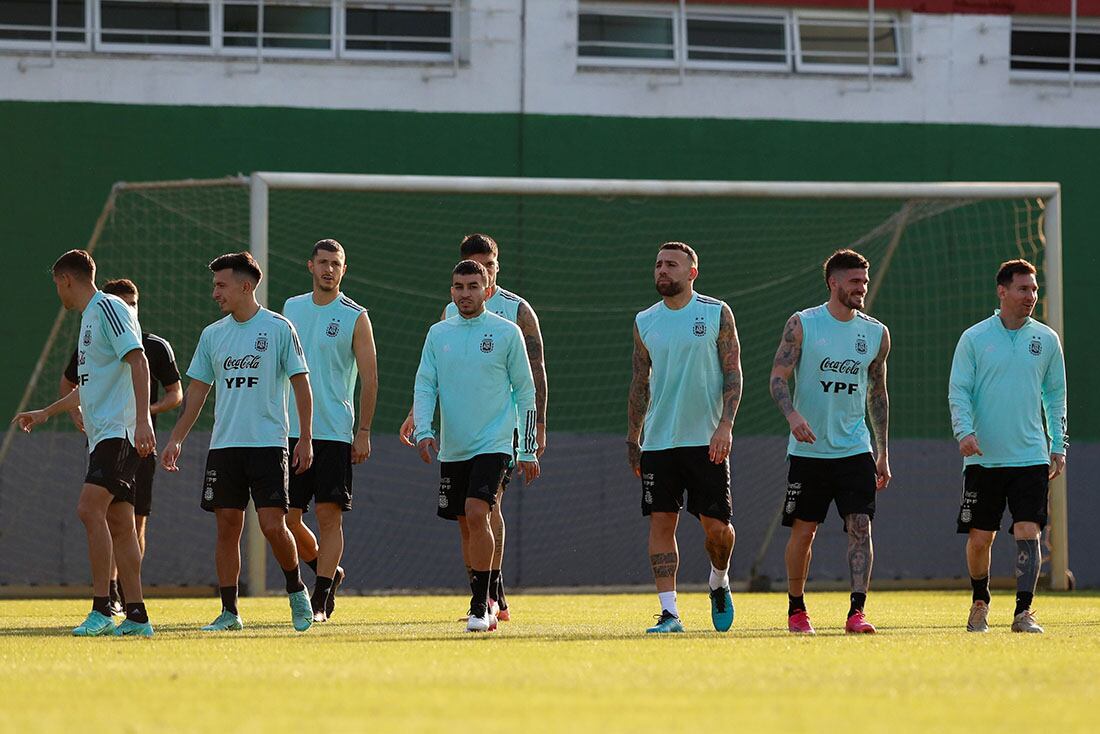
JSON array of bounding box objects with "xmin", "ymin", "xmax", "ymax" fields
[{"xmin": 201, "ymin": 446, "xmax": 289, "ymax": 512}]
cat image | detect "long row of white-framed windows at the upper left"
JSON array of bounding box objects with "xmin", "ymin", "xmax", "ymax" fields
[{"xmin": 0, "ymin": 0, "xmax": 459, "ymax": 62}]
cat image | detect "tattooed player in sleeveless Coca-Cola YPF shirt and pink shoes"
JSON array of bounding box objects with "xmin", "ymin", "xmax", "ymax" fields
[{"xmin": 771, "ymin": 250, "xmax": 890, "ymax": 635}]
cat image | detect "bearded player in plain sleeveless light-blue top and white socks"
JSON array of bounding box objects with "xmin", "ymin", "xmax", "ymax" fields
[{"xmin": 626, "ymin": 242, "xmax": 741, "ymax": 633}]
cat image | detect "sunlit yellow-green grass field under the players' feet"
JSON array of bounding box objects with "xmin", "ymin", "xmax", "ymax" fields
[{"xmin": 0, "ymin": 592, "xmax": 1100, "ymax": 734}]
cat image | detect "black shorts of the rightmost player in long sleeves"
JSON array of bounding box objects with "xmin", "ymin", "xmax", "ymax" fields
[{"xmin": 957, "ymin": 464, "xmax": 1049, "ymax": 533}]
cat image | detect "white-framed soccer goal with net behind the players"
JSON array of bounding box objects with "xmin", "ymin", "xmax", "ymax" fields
[{"xmin": 0, "ymin": 172, "xmax": 1068, "ymax": 594}]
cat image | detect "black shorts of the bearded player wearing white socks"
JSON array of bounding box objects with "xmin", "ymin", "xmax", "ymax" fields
[{"xmin": 641, "ymin": 446, "xmax": 734, "ymax": 523}]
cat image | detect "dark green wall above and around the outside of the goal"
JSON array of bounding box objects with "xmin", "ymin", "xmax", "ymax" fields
[{"xmin": 0, "ymin": 102, "xmax": 1100, "ymax": 440}]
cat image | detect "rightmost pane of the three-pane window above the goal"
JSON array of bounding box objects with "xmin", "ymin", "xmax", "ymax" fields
[{"xmin": 794, "ymin": 12, "xmax": 904, "ymax": 75}]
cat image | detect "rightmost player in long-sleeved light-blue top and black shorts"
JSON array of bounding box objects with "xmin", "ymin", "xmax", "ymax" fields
[{"xmin": 947, "ymin": 260, "xmax": 1069, "ymax": 633}]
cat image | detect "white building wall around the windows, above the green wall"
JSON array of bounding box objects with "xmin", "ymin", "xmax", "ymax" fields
[{"xmin": 0, "ymin": 0, "xmax": 1100, "ymax": 128}]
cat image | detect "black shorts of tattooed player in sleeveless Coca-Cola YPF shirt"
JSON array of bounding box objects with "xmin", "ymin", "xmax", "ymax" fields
[{"xmin": 783, "ymin": 453, "xmax": 878, "ymax": 530}]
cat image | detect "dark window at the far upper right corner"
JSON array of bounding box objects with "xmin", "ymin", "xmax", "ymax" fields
[{"xmin": 1009, "ymin": 18, "xmax": 1100, "ymax": 78}]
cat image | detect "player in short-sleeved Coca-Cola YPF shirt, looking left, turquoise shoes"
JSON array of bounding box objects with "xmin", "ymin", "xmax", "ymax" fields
[{"xmin": 161, "ymin": 252, "xmax": 314, "ymax": 632}]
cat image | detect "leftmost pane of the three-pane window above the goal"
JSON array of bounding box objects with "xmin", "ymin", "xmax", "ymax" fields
[{"xmin": 578, "ymin": 7, "xmax": 678, "ymax": 66}]
